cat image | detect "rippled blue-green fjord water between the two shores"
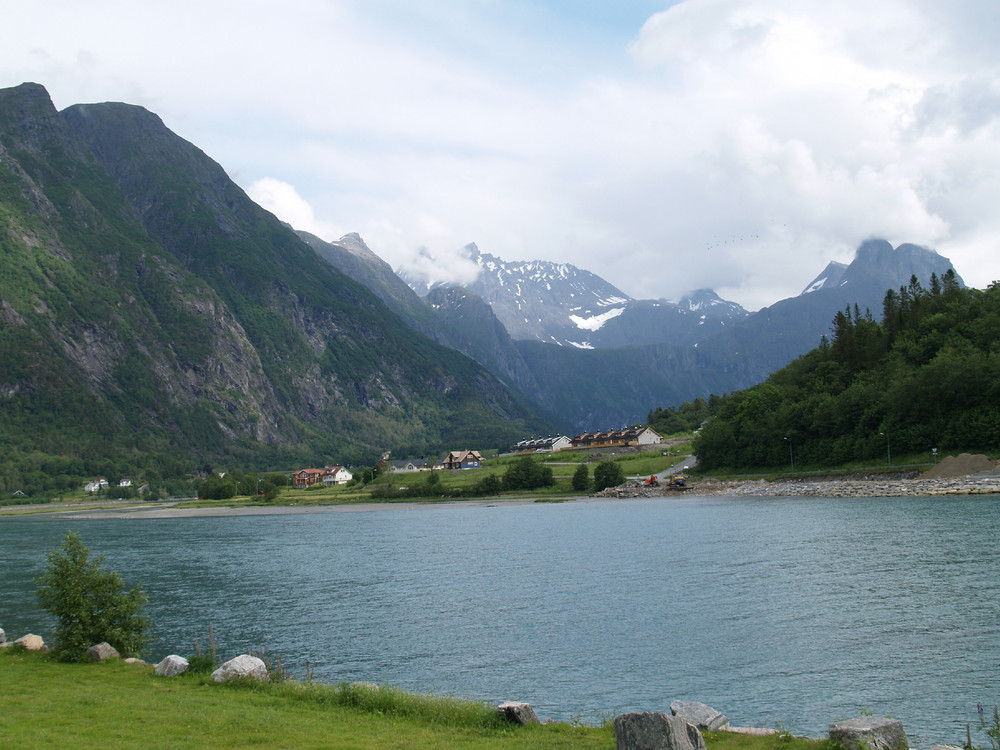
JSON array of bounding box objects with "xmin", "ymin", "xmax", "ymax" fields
[{"xmin": 0, "ymin": 496, "xmax": 1000, "ymax": 747}]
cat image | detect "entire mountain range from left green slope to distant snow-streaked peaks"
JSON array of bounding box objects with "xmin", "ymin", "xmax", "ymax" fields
[{"xmin": 0, "ymin": 84, "xmax": 968, "ymax": 482}]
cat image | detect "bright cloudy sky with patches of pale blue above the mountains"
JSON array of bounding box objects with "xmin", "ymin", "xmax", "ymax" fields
[{"xmin": 0, "ymin": 0, "xmax": 1000, "ymax": 309}]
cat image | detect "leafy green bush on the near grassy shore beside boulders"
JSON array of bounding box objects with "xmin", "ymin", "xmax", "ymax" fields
[{"xmin": 37, "ymin": 531, "xmax": 152, "ymax": 661}]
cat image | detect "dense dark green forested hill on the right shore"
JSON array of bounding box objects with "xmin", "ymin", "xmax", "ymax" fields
[{"xmin": 688, "ymin": 273, "xmax": 1000, "ymax": 469}]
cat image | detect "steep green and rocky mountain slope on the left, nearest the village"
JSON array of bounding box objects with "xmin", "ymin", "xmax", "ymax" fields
[{"xmin": 0, "ymin": 84, "xmax": 545, "ymax": 482}]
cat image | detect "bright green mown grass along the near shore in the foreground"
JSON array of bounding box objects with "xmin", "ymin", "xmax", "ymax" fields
[{"xmin": 0, "ymin": 649, "xmax": 831, "ymax": 750}]
